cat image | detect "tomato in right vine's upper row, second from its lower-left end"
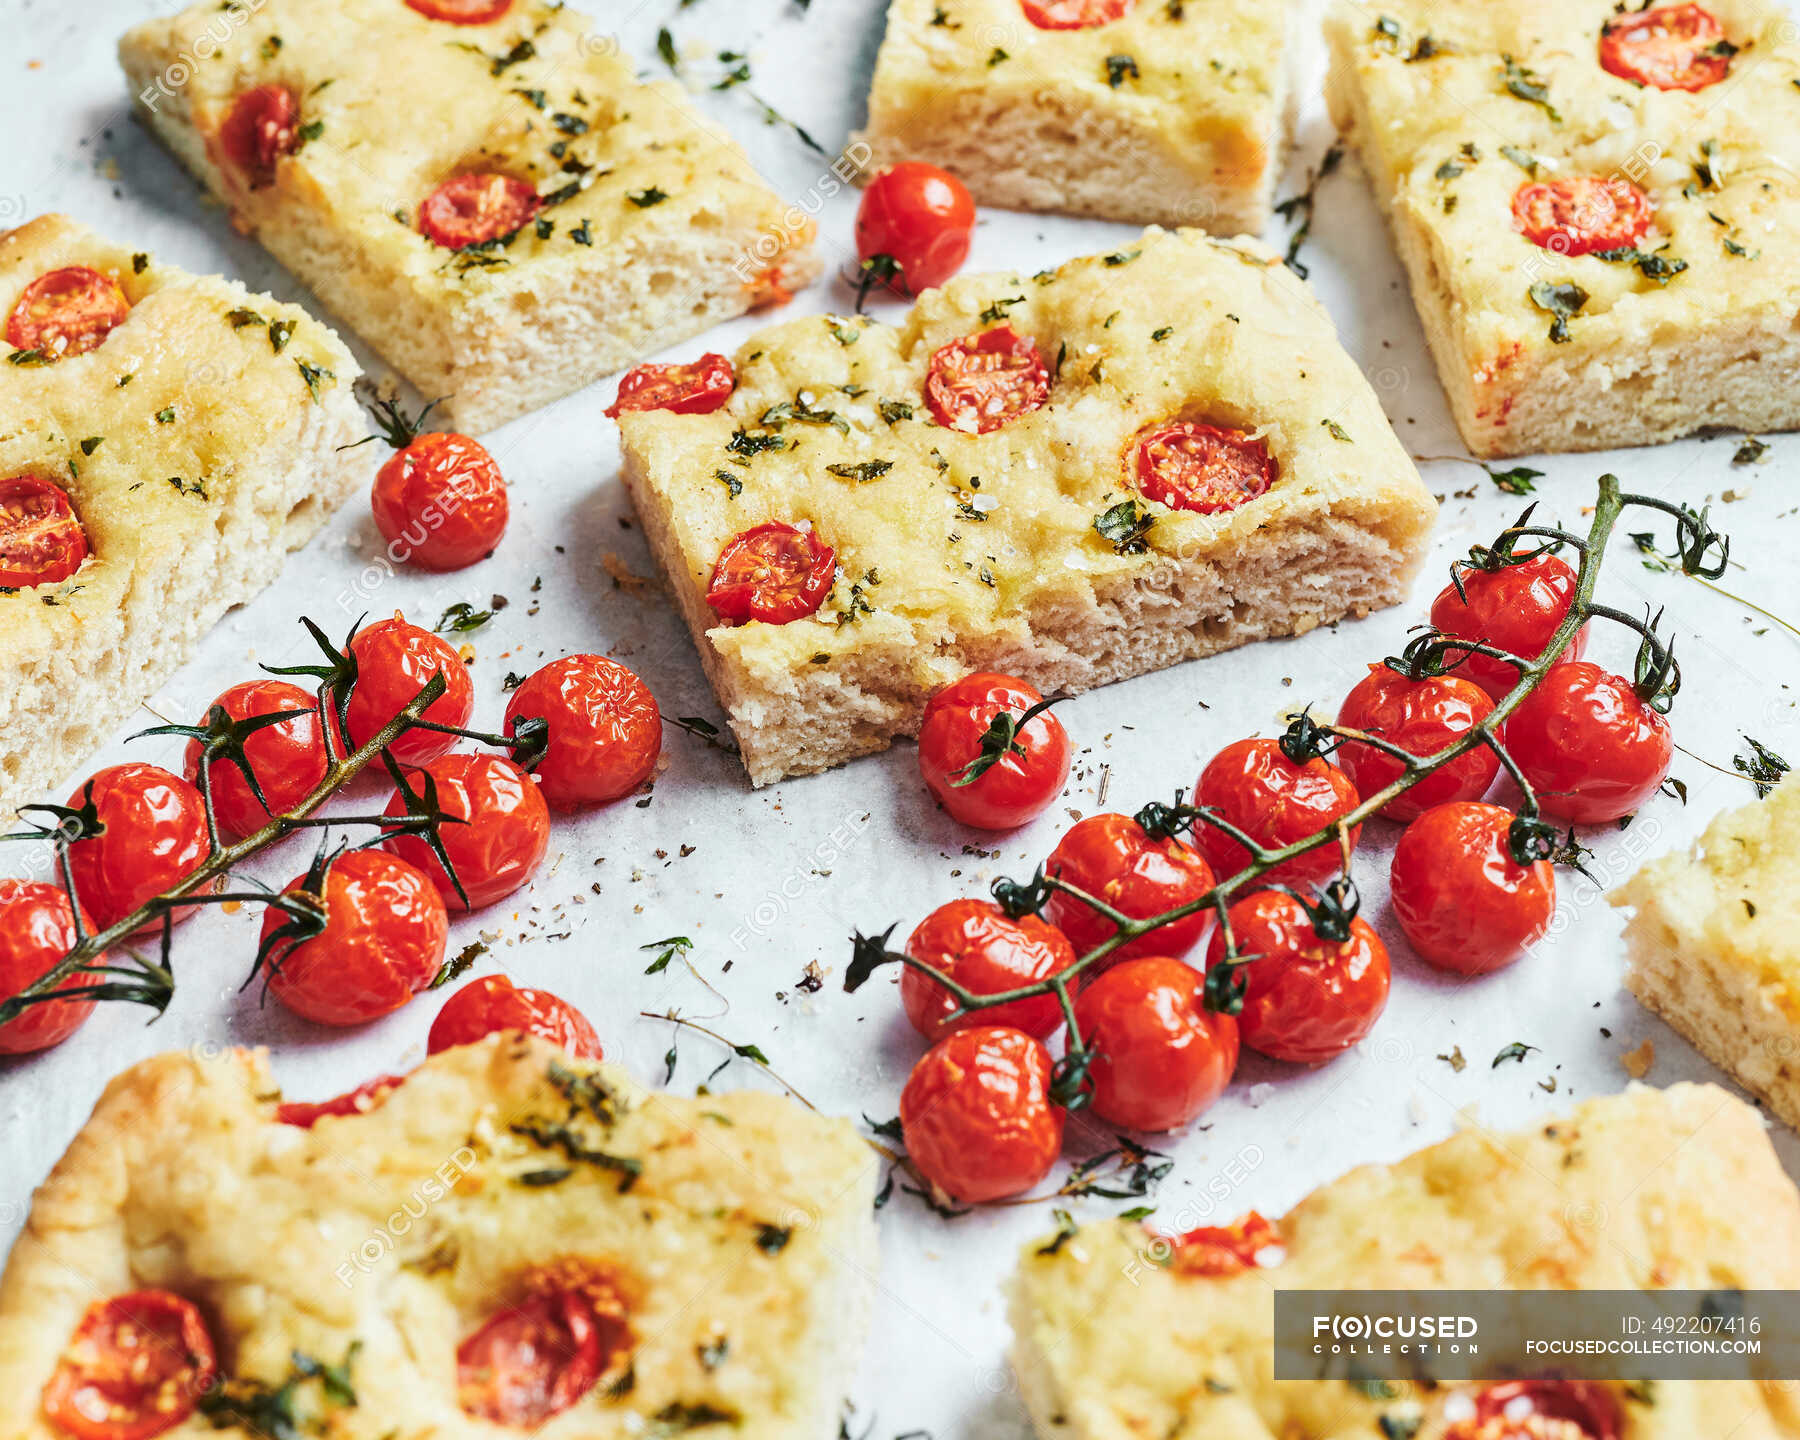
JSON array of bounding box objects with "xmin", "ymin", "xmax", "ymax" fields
[{"xmin": 1044, "ymin": 814, "xmax": 1213, "ymax": 979}]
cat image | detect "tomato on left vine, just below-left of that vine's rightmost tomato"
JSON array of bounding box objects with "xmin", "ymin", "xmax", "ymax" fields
[{"xmin": 383, "ymin": 752, "xmax": 551, "ymax": 911}]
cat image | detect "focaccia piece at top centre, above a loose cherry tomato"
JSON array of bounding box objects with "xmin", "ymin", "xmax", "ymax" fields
[{"xmin": 855, "ymin": 0, "xmax": 1296, "ymax": 236}]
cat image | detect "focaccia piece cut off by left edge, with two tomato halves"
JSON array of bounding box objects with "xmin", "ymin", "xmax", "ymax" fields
[{"xmin": 0, "ymin": 214, "xmax": 365, "ymax": 814}]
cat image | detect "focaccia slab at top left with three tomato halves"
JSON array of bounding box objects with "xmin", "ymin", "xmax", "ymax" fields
[{"xmin": 119, "ymin": 0, "xmax": 817, "ymax": 432}]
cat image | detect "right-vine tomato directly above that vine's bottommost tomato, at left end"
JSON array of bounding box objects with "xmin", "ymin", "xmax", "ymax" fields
[{"xmin": 900, "ymin": 900, "xmax": 1075, "ymax": 1040}]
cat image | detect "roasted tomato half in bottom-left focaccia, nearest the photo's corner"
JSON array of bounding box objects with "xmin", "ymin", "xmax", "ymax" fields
[{"xmin": 43, "ymin": 1291, "xmax": 218, "ymax": 1440}]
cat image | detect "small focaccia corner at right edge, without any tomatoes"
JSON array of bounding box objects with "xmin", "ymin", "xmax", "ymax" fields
[{"xmin": 1609, "ymin": 776, "xmax": 1800, "ymax": 1129}]
